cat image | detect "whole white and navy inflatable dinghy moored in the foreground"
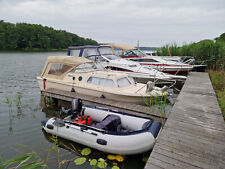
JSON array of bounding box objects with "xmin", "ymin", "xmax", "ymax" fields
[{"xmin": 42, "ymin": 98, "xmax": 161, "ymax": 155}]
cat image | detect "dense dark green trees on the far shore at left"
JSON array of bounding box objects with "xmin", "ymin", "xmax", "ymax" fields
[{"xmin": 0, "ymin": 21, "xmax": 98, "ymax": 50}]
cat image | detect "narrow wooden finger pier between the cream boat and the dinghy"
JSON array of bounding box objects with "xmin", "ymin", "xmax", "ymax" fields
[{"xmin": 41, "ymin": 89, "xmax": 169, "ymax": 121}]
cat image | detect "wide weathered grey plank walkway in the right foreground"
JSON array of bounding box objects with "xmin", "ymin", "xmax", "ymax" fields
[{"xmin": 145, "ymin": 72, "xmax": 225, "ymax": 169}]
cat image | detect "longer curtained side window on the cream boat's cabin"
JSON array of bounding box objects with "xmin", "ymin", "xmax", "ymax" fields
[{"xmin": 87, "ymin": 77, "xmax": 114, "ymax": 87}]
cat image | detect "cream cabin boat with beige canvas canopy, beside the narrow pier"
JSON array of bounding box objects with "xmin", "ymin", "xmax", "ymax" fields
[{"xmin": 37, "ymin": 56, "xmax": 168, "ymax": 104}]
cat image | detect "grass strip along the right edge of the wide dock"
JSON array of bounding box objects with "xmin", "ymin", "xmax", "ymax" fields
[{"xmin": 208, "ymin": 70, "xmax": 225, "ymax": 119}]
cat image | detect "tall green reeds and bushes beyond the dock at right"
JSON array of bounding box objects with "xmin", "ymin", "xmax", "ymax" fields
[{"xmin": 157, "ymin": 33, "xmax": 225, "ymax": 69}]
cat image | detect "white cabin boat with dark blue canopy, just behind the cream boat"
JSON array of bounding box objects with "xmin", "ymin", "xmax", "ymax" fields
[{"xmin": 68, "ymin": 45, "xmax": 186, "ymax": 84}]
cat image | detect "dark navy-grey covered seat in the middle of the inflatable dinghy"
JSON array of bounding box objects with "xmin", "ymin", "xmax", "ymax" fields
[{"xmin": 91, "ymin": 114, "xmax": 122, "ymax": 132}]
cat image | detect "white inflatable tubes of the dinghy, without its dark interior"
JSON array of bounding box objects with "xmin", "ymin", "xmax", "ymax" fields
[{"xmin": 43, "ymin": 105, "xmax": 161, "ymax": 155}]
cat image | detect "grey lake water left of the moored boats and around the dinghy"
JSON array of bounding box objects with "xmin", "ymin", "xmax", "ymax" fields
[{"xmin": 0, "ymin": 52, "xmax": 148, "ymax": 169}]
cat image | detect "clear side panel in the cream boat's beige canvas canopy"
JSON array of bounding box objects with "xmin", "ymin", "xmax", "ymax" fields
[{"xmin": 48, "ymin": 63, "xmax": 72, "ymax": 76}]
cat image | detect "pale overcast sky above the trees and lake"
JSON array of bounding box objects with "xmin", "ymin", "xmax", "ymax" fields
[{"xmin": 0, "ymin": 0, "xmax": 225, "ymax": 47}]
